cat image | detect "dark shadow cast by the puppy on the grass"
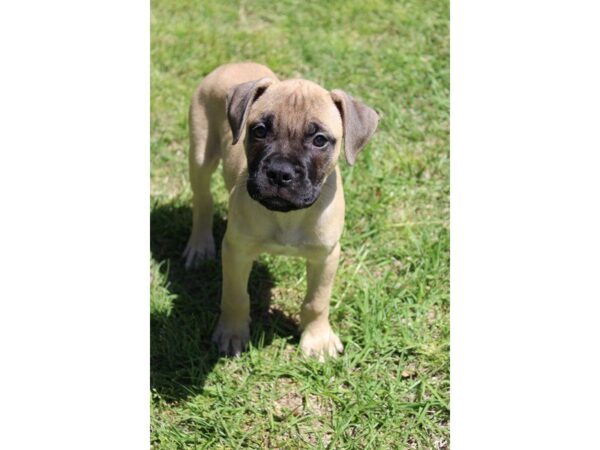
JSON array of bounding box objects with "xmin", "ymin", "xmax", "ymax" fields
[{"xmin": 150, "ymin": 203, "xmax": 298, "ymax": 400}]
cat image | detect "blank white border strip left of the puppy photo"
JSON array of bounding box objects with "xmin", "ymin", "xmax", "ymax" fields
[{"xmin": 0, "ymin": 0, "xmax": 150, "ymax": 450}]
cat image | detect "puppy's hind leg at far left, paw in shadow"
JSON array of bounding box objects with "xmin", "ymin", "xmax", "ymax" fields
[{"xmin": 183, "ymin": 91, "xmax": 221, "ymax": 269}]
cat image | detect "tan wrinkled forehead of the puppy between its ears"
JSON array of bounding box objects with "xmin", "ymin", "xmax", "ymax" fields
[{"xmin": 249, "ymin": 80, "xmax": 342, "ymax": 138}]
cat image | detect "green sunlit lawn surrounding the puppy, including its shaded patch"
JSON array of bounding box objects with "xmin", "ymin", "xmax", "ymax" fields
[{"xmin": 151, "ymin": 0, "xmax": 450, "ymax": 449}]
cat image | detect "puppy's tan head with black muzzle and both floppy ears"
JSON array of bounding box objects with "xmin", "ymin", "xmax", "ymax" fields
[{"xmin": 227, "ymin": 78, "xmax": 379, "ymax": 212}]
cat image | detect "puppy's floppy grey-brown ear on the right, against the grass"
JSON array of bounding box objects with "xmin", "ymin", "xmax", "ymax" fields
[{"xmin": 331, "ymin": 89, "xmax": 379, "ymax": 165}]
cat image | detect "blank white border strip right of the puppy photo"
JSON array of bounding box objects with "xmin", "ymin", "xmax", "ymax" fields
[{"xmin": 451, "ymin": 0, "xmax": 600, "ymax": 450}]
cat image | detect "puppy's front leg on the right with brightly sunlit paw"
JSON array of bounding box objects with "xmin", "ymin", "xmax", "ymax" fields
[{"xmin": 300, "ymin": 243, "xmax": 344, "ymax": 360}]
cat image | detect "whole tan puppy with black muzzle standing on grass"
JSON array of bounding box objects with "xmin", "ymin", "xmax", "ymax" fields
[{"xmin": 184, "ymin": 63, "xmax": 379, "ymax": 360}]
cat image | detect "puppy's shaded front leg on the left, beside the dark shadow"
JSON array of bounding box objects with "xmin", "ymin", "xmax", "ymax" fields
[{"xmin": 213, "ymin": 233, "xmax": 255, "ymax": 356}]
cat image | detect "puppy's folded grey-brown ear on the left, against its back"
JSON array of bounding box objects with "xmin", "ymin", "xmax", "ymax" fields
[{"xmin": 226, "ymin": 77, "xmax": 273, "ymax": 145}]
